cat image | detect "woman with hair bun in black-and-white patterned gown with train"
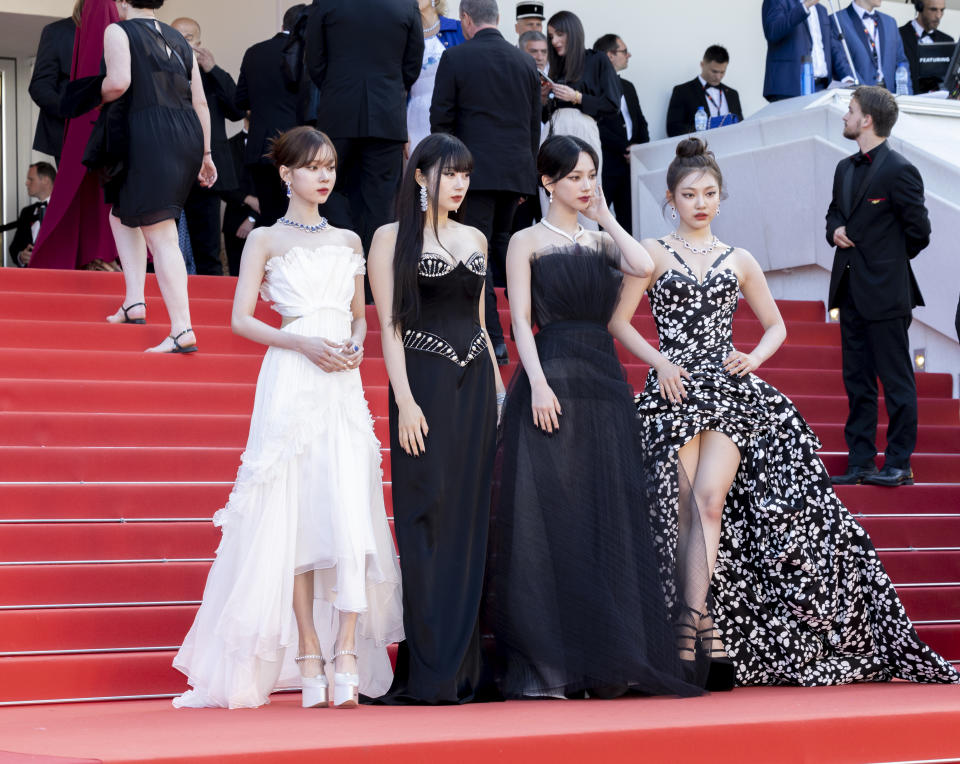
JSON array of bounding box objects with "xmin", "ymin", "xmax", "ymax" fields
[{"xmin": 610, "ymin": 138, "xmax": 960, "ymax": 686}]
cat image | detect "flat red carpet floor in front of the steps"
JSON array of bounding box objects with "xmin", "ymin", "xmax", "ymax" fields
[{"xmin": 0, "ymin": 683, "xmax": 960, "ymax": 764}]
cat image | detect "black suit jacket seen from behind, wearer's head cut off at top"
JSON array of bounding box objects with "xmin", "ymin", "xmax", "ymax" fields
[{"xmin": 306, "ymin": 0, "xmax": 423, "ymax": 141}]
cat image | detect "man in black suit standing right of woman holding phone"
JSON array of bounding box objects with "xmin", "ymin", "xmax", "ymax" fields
[{"xmin": 593, "ymin": 34, "xmax": 650, "ymax": 236}]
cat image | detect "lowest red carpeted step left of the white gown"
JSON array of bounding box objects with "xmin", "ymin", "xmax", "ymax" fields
[{"xmin": 0, "ymin": 650, "xmax": 187, "ymax": 703}]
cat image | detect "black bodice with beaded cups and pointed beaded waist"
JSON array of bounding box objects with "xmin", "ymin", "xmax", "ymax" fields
[{"xmin": 403, "ymin": 252, "xmax": 487, "ymax": 368}]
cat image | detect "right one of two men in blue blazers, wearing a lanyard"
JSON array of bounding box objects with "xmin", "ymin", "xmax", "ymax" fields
[{"xmin": 837, "ymin": 0, "xmax": 913, "ymax": 93}]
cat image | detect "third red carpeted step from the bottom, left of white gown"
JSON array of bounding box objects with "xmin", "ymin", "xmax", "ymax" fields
[{"xmin": 0, "ymin": 562, "xmax": 210, "ymax": 609}]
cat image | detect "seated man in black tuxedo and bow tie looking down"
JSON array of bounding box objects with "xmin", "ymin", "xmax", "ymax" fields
[{"xmin": 667, "ymin": 45, "xmax": 743, "ymax": 138}]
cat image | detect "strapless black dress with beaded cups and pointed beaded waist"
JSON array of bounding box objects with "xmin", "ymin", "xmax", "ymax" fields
[{"xmin": 378, "ymin": 252, "xmax": 497, "ymax": 704}]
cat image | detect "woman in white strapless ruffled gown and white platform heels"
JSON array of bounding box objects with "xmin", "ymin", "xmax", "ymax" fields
[{"xmin": 173, "ymin": 127, "xmax": 403, "ymax": 708}]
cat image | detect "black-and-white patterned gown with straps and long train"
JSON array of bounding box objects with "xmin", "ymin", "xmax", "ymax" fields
[{"xmin": 636, "ymin": 241, "xmax": 960, "ymax": 685}]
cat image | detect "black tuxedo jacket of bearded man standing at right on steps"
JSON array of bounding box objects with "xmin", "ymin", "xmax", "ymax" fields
[{"xmin": 827, "ymin": 144, "xmax": 930, "ymax": 321}]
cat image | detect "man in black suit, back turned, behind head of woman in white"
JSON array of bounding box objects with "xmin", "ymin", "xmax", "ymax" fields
[{"xmin": 234, "ymin": 3, "xmax": 306, "ymax": 226}]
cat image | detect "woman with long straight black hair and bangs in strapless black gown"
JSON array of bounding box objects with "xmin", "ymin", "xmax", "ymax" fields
[{"xmin": 368, "ymin": 133, "xmax": 503, "ymax": 704}]
